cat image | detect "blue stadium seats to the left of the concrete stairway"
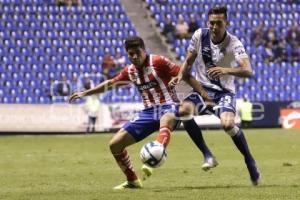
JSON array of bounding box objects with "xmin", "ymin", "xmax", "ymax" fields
[{"xmin": 0, "ymin": 0, "xmax": 136, "ymax": 103}]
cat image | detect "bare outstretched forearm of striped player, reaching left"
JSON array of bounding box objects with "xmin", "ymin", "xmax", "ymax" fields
[{"xmin": 69, "ymin": 79, "xmax": 117, "ymax": 103}]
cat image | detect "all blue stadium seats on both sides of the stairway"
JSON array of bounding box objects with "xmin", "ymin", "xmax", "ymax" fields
[{"xmin": 0, "ymin": 0, "xmax": 300, "ymax": 104}]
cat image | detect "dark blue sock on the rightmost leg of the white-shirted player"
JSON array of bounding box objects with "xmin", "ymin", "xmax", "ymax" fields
[{"xmin": 231, "ymin": 129, "xmax": 254, "ymax": 162}]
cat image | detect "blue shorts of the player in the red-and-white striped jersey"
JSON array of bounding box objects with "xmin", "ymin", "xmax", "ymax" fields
[{"xmin": 123, "ymin": 104, "xmax": 179, "ymax": 141}]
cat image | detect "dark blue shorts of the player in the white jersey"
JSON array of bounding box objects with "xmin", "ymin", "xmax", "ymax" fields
[{"xmin": 184, "ymin": 91, "xmax": 236, "ymax": 117}]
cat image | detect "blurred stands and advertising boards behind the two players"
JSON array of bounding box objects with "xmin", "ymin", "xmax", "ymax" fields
[{"xmin": 0, "ymin": 0, "xmax": 300, "ymax": 134}]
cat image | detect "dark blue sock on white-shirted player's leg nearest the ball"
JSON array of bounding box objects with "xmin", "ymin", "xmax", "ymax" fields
[{"xmin": 183, "ymin": 119, "xmax": 213, "ymax": 158}]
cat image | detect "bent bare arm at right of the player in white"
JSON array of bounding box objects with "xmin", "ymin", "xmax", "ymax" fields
[{"xmin": 227, "ymin": 58, "xmax": 253, "ymax": 78}]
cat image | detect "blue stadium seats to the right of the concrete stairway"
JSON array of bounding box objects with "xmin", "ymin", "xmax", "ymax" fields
[{"xmin": 145, "ymin": 0, "xmax": 300, "ymax": 101}]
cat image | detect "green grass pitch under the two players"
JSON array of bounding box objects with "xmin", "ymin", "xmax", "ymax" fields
[{"xmin": 0, "ymin": 129, "xmax": 300, "ymax": 200}]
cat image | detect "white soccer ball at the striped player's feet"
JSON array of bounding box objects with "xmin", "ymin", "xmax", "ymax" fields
[{"xmin": 140, "ymin": 141, "xmax": 167, "ymax": 167}]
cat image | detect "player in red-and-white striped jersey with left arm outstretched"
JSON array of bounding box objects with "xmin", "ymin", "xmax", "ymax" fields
[{"xmin": 69, "ymin": 37, "xmax": 213, "ymax": 190}]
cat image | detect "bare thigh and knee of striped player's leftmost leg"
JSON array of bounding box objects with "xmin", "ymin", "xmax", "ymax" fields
[{"xmin": 109, "ymin": 128, "xmax": 136, "ymax": 153}]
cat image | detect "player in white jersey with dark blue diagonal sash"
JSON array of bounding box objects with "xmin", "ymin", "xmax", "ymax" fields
[{"xmin": 169, "ymin": 7, "xmax": 260, "ymax": 185}]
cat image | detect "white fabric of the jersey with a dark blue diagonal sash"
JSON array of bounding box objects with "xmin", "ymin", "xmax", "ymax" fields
[{"xmin": 188, "ymin": 28, "xmax": 248, "ymax": 94}]
